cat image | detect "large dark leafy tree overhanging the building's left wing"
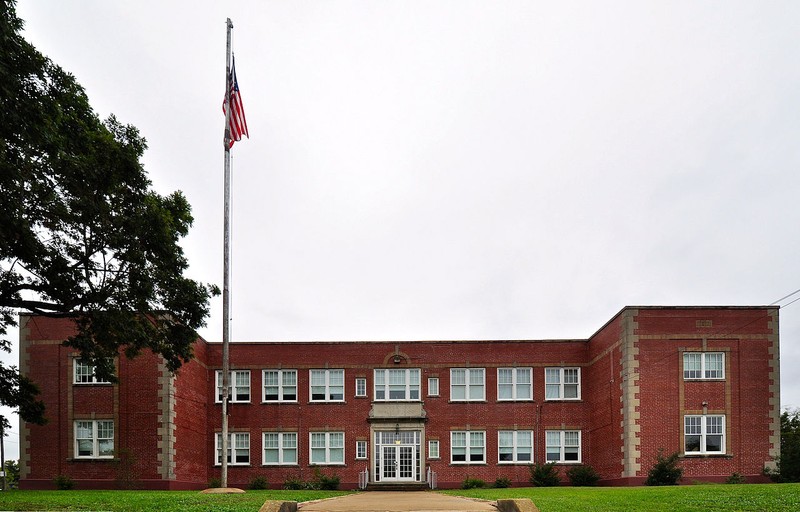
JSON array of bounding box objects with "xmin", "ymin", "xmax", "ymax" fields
[{"xmin": 0, "ymin": 0, "xmax": 219, "ymax": 422}]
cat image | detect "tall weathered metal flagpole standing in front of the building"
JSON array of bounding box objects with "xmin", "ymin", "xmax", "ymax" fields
[{"xmin": 220, "ymin": 18, "xmax": 233, "ymax": 488}]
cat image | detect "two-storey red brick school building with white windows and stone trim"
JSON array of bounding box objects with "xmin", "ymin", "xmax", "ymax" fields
[{"xmin": 20, "ymin": 306, "xmax": 780, "ymax": 489}]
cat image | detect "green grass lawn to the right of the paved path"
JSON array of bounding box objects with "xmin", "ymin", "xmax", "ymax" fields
[{"xmin": 445, "ymin": 484, "xmax": 800, "ymax": 512}]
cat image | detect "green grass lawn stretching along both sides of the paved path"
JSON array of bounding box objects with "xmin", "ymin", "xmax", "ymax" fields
[{"xmin": 0, "ymin": 484, "xmax": 800, "ymax": 512}]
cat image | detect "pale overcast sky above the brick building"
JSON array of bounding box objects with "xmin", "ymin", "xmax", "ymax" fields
[{"xmin": 6, "ymin": 0, "xmax": 800, "ymax": 458}]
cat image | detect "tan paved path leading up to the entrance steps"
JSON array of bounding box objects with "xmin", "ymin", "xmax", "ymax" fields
[{"xmin": 297, "ymin": 491, "xmax": 497, "ymax": 512}]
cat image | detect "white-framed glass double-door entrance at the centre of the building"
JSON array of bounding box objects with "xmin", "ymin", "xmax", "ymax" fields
[{"xmin": 374, "ymin": 430, "xmax": 422, "ymax": 482}]
